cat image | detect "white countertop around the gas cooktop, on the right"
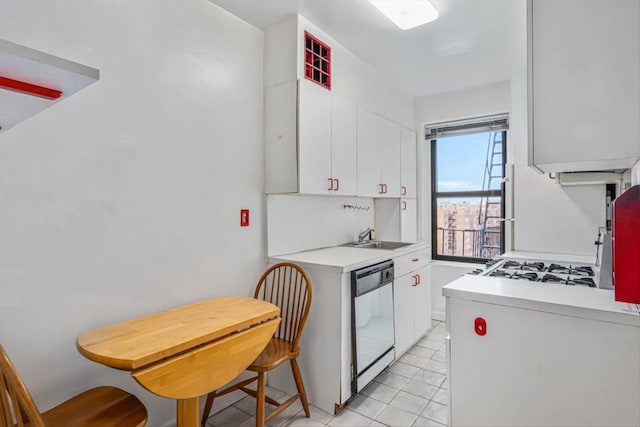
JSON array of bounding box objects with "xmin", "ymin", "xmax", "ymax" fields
[{"xmin": 442, "ymin": 275, "xmax": 640, "ymax": 328}]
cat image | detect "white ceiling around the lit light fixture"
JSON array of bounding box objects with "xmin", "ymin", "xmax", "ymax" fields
[{"xmin": 211, "ymin": 0, "xmax": 526, "ymax": 96}]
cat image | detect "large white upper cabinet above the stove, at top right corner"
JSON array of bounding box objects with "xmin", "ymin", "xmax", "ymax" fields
[{"xmin": 528, "ymin": 0, "xmax": 640, "ymax": 172}]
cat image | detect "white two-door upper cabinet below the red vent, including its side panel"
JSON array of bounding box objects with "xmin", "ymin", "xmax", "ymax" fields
[{"xmin": 265, "ymin": 80, "xmax": 357, "ymax": 196}]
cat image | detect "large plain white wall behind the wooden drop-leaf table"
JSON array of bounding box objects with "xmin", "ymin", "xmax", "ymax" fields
[{"xmin": 0, "ymin": 0, "xmax": 265, "ymax": 426}]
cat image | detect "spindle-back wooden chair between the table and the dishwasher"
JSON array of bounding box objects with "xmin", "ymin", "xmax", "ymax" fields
[{"xmin": 202, "ymin": 262, "xmax": 311, "ymax": 427}]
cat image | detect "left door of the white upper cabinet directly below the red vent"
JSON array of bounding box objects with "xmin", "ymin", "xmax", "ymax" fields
[{"xmin": 298, "ymin": 80, "xmax": 333, "ymax": 194}]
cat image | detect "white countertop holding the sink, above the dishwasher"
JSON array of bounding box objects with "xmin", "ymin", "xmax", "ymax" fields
[{"xmin": 269, "ymin": 243, "xmax": 429, "ymax": 272}]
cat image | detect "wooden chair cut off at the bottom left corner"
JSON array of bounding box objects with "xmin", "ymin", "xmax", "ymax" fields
[{"xmin": 0, "ymin": 345, "xmax": 147, "ymax": 427}]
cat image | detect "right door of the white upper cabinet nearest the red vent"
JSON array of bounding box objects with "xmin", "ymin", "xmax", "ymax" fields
[{"xmin": 331, "ymin": 95, "xmax": 358, "ymax": 196}]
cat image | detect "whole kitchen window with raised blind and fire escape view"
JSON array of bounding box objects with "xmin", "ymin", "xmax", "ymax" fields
[{"xmin": 426, "ymin": 115, "xmax": 509, "ymax": 262}]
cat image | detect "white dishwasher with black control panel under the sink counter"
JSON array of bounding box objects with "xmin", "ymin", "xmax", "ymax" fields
[{"xmin": 351, "ymin": 261, "xmax": 395, "ymax": 395}]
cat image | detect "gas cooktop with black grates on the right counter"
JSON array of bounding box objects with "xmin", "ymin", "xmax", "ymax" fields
[{"xmin": 471, "ymin": 258, "xmax": 598, "ymax": 288}]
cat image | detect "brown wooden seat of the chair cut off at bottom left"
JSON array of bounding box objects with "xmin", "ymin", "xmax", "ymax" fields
[{"xmin": 41, "ymin": 386, "xmax": 147, "ymax": 427}]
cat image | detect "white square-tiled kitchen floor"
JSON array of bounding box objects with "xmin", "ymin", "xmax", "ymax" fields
[{"xmin": 208, "ymin": 321, "xmax": 449, "ymax": 427}]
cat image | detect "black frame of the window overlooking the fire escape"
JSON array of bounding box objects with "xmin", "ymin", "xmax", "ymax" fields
[{"xmin": 427, "ymin": 129, "xmax": 507, "ymax": 263}]
